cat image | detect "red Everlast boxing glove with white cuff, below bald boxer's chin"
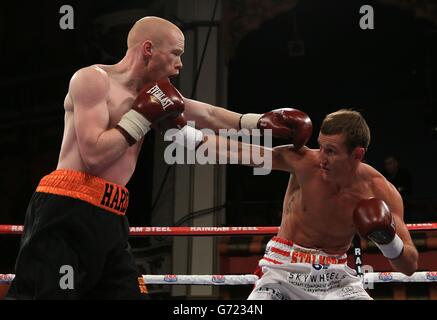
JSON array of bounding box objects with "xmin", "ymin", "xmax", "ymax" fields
[{"xmin": 117, "ymin": 78, "xmax": 186, "ymax": 145}]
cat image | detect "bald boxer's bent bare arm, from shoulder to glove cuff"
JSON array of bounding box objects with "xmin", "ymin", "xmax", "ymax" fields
[{"xmin": 69, "ymin": 67, "xmax": 129, "ymax": 174}]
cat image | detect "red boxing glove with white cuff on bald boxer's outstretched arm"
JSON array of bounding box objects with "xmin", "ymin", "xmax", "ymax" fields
[{"xmin": 240, "ymin": 108, "xmax": 313, "ymax": 150}]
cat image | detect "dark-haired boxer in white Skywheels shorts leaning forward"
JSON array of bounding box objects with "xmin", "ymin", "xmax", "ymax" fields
[{"xmin": 233, "ymin": 109, "xmax": 418, "ymax": 299}]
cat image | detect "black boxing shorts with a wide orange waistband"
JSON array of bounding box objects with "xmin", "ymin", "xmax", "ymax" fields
[{"xmin": 6, "ymin": 170, "xmax": 147, "ymax": 299}]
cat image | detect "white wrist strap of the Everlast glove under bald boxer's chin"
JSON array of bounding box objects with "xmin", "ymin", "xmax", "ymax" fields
[{"xmin": 117, "ymin": 109, "xmax": 151, "ymax": 145}]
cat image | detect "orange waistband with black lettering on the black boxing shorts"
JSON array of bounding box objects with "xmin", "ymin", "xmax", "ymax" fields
[{"xmin": 36, "ymin": 170, "xmax": 129, "ymax": 215}]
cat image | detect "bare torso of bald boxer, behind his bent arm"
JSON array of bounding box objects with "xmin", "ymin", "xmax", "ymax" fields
[{"xmin": 57, "ymin": 65, "xmax": 142, "ymax": 185}]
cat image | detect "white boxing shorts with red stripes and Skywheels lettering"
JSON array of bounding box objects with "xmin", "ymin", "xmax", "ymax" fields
[{"xmin": 248, "ymin": 237, "xmax": 372, "ymax": 300}]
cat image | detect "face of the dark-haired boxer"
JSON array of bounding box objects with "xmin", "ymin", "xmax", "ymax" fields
[{"xmin": 318, "ymin": 133, "xmax": 355, "ymax": 181}]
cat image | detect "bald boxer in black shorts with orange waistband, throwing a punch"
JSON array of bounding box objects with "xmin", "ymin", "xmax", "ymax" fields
[{"xmin": 8, "ymin": 17, "xmax": 306, "ymax": 299}]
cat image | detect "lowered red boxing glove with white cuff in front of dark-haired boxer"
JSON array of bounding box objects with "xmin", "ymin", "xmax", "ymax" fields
[{"xmin": 353, "ymin": 198, "xmax": 404, "ymax": 259}]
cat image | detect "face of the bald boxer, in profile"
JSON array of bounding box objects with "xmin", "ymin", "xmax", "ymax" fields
[{"xmin": 152, "ymin": 30, "xmax": 185, "ymax": 79}]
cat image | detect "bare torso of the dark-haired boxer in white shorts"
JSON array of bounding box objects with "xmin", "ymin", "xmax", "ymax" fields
[{"xmin": 278, "ymin": 151, "xmax": 378, "ymax": 254}]
